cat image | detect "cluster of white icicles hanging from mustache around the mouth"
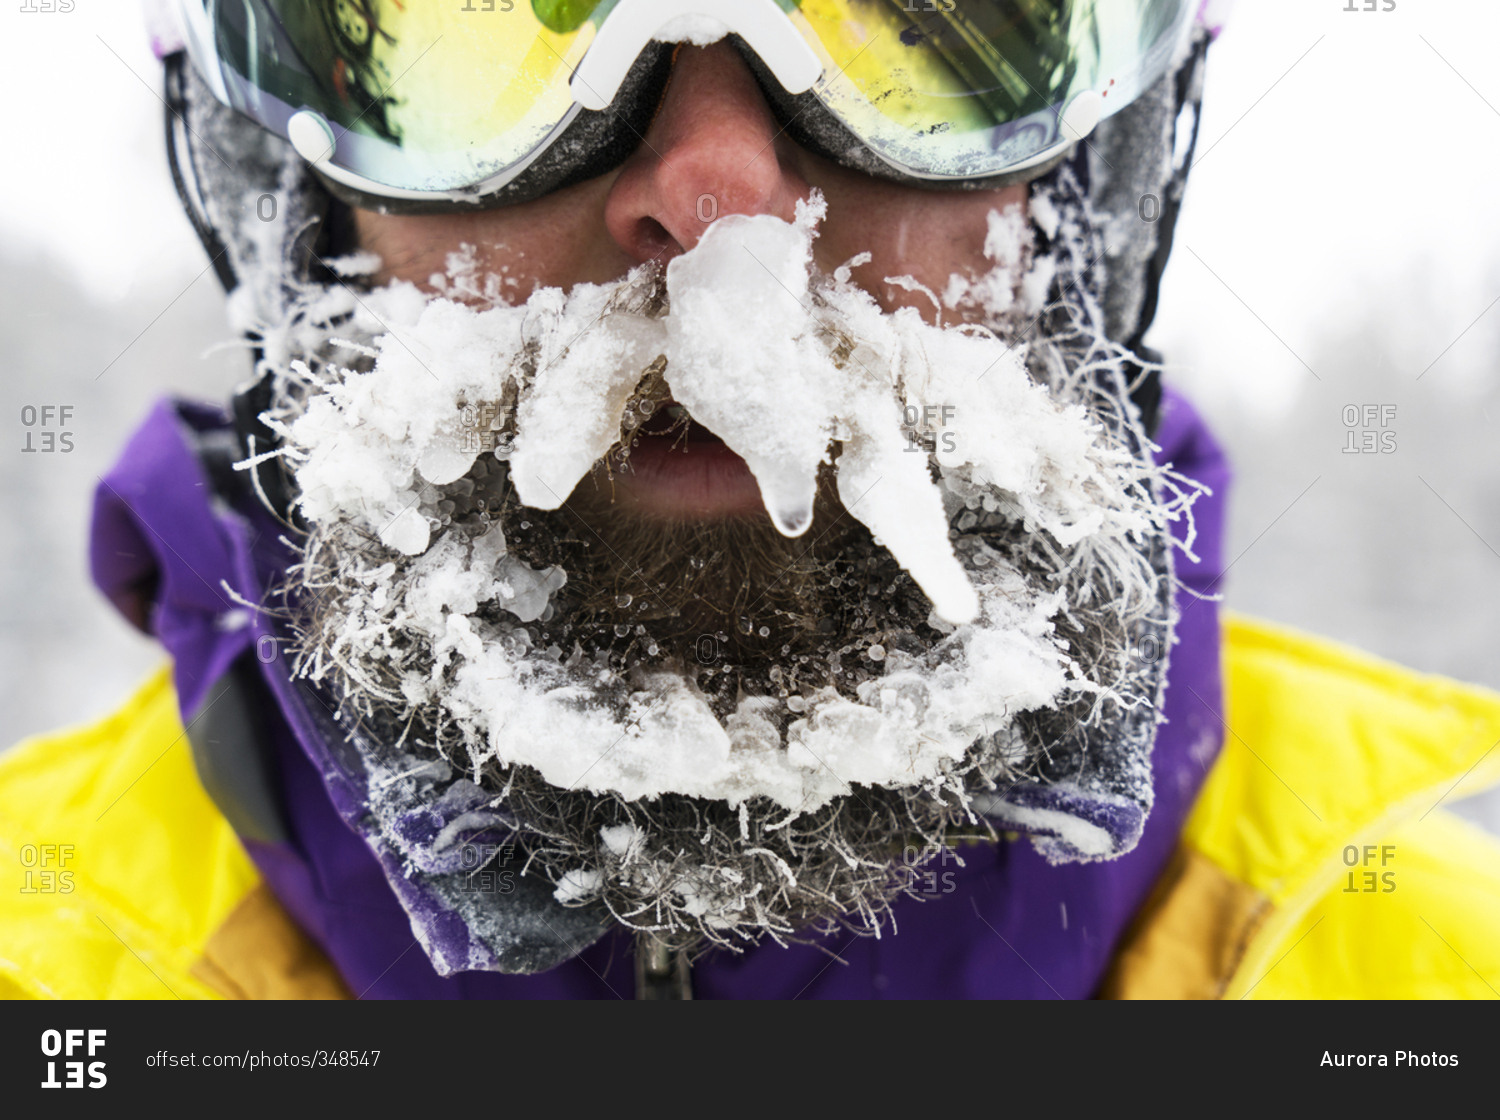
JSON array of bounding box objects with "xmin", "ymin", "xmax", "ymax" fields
[{"xmin": 510, "ymin": 196, "xmax": 1002, "ymax": 624}]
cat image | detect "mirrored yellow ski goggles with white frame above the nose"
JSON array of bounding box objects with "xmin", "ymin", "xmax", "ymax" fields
[{"xmin": 176, "ymin": 0, "xmax": 1193, "ymax": 211}]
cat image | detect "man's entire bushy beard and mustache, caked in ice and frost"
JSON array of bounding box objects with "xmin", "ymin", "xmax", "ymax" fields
[{"xmin": 269, "ymin": 188, "xmax": 1181, "ymax": 946}]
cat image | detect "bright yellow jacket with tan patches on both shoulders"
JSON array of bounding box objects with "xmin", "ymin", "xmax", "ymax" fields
[{"xmin": 0, "ymin": 616, "xmax": 1500, "ymax": 999}]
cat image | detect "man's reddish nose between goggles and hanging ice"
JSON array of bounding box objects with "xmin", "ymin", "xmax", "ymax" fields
[{"xmin": 605, "ymin": 42, "xmax": 810, "ymax": 262}]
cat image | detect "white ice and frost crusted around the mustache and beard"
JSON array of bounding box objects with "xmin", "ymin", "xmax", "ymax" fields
[{"xmin": 258, "ymin": 190, "xmax": 1175, "ymax": 947}]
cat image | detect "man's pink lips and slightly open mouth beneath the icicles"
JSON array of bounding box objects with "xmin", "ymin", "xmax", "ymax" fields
[{"xmin": 611, "ymin": 400, "xmax": 765, "ymax": 522}]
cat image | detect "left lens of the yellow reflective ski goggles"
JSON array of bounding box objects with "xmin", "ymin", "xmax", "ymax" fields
[{"xmin": 209, "ymin": 0, "xmax": 599, "ymax": 192}]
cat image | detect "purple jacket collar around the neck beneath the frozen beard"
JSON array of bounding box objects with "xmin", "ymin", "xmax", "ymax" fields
[{"xmin": 90, "ymin": 391, "xmax": 1229, "ymax": 999}]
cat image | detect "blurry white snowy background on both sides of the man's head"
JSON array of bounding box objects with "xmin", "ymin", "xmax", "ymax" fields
[{"xmin": 0, "ymin": 0, "xmax": 1500, "ymax": 831}]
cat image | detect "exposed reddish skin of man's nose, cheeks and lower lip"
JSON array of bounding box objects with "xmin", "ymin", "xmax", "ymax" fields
[{"xmin": 356, "ymin": 42, "xmax": 1028, "ymax": 386}]
